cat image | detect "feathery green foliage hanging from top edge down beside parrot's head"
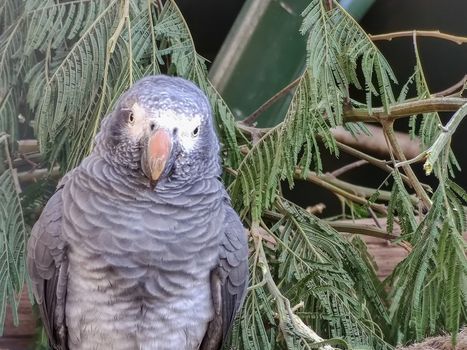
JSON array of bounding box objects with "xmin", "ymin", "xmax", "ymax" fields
[{"xmin": 233, "ymin": 1, "xmax": 395, "ymax": 220}]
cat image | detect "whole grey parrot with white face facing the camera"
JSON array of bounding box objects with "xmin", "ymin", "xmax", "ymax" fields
[{"xmin": 27, "ymin": 75, "xmax": 248, "ymax": 350}]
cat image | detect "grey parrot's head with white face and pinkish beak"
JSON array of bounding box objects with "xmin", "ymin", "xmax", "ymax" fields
[{"xmin": 101, "ymin": 75, "xmax": 220, "ymax": 187}]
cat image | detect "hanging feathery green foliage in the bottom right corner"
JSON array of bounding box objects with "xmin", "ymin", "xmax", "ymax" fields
[{"xmin": 391, "ymin": 181, "xmax": 467, "ymax": 340}]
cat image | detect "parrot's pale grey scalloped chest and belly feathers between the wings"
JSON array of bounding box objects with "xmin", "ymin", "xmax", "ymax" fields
[{"xmin": 63, "ymin": 160, "xmax": 224, "ymax": 350}]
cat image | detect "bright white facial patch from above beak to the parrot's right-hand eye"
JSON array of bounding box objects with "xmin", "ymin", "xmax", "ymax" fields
[{"xmin": 157, "ymin": 110, "xmax": 201, "ymax": 152}]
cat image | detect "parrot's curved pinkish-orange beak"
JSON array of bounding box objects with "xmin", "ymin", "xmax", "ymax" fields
[{"xmin": 142, "ymin": 129, "xmax": 172, "ymax": 182}]
